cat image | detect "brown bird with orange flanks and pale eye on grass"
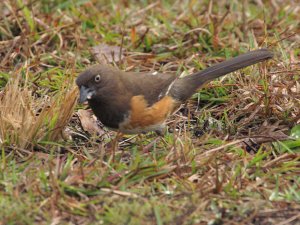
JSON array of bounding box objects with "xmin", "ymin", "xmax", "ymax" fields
[{"xmin": 76, "ymin": 48, "xmax": 273, "ymax": 134}]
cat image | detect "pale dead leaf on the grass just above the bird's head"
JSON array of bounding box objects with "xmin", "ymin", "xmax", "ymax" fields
[{"xmin": 91, "ymin": 44, "xmax": 124, "ymax": 64}]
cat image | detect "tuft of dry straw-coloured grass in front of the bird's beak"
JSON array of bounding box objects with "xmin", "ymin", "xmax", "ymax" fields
[{"xmin": 0, "ymin": 72, "xmax": 78, "ymax": 149}]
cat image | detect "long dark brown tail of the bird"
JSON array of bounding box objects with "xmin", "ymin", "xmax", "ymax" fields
[{"xmin": 169, "ymin": 49, "xmax": 273, "ymax": 101}]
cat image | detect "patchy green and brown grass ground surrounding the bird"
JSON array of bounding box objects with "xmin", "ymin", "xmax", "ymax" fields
[{"xmin": 0, "ymin": 0, "xmax": 300, "ymax": 225}]
